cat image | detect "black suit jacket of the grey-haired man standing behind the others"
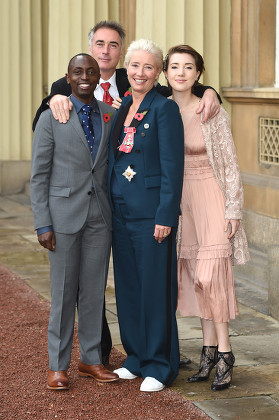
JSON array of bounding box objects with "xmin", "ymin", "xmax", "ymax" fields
[{"xmin": 32, "ymin": 68, "xmax": 222, "ymax": 131}]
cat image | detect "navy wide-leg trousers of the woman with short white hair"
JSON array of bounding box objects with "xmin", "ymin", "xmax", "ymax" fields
[{"xmin": 113, "ymin": 197, "xmax": 179, "ymax": 385}]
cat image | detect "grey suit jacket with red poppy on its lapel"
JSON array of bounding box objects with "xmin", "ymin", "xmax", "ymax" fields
[{"xmin": 30, "ymin": 101, "xmax": 115, "ymax": 234}]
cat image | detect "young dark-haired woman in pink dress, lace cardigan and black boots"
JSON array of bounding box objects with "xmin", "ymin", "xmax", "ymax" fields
[{"xmin": 164, "ymin": 45, "xmax": 249, "ymax": 391}]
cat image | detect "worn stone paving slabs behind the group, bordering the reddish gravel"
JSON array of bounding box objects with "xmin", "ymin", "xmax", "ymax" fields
[{"xmin": 0, "ymin": 195, "xmax": 279, "ymax": 420}]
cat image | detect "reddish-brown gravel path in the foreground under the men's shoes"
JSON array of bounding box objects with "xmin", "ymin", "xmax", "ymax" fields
[{"xmin": 0, "ymin": 265, "xmax": 210, "ymax": 420}]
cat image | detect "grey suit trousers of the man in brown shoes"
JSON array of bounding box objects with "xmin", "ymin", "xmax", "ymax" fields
[{"xmin": 48, "ymin": 192, "xmax": 111, "ymax": 371}]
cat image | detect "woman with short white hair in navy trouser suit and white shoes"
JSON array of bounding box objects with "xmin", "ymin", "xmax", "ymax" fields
[{"xmin": 108, "ymin": 39, "xmax": 184, "ymax": 392}]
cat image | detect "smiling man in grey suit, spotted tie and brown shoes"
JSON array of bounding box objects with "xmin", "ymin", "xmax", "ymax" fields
[{"xmin": 30, "ymin": 54, "xmax": 118, "ymax": 390}]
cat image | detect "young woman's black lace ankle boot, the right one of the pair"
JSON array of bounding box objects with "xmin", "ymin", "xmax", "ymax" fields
[{"xmin": 211, "ymin": 351, "xmax": 235, "ymax": 391}]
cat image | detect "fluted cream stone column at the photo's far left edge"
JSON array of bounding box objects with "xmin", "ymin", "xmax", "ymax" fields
[{"xmin": 0, "ymin": 0, "xmax": 43, "ymax": 193}]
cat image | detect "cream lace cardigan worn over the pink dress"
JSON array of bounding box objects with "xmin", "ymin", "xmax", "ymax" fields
[{"xmin": 201, "ymin": 106, "xmax": 250, "ymax": 265}]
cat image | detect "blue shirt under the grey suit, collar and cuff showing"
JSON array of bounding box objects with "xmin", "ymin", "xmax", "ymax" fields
[{"xmin": 37, "ymin": 95, "xmax": 102, "ymax": 236}]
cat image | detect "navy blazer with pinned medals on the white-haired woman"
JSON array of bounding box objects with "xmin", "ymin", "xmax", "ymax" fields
[{"xmin": 108, "ymin": 88, "xmax": 184, "ymax": 226}]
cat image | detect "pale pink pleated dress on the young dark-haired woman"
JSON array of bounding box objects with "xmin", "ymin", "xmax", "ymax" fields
[{"xmin": 178, "ymin": 114, "xmax": 238, "ymax": 322}]
